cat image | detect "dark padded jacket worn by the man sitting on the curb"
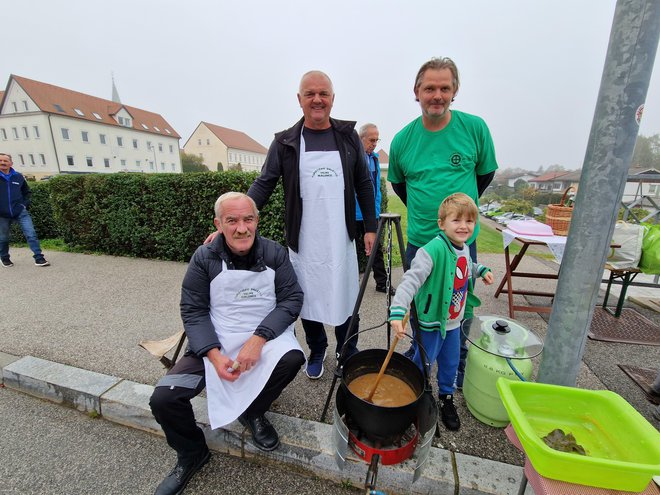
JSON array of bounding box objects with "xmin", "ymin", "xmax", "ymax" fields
[{"xmin": 181, "ymin": 234, "xmax": 303, "ymax": 357}]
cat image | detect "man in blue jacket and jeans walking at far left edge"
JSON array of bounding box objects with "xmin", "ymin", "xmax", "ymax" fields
[{"xmin": 0, "ymin": 153, "xmax": 50, "ymax": 268}]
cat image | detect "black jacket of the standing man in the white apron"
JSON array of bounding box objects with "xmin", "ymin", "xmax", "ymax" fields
[{"xmin": 247, "ymin": 119, "xmax": 377, "ymax": 252}]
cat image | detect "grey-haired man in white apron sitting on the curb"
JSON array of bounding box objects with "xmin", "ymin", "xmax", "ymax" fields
[{"xmin": 150, "ymin": 192, "xmax": 305, "ymax": 495}]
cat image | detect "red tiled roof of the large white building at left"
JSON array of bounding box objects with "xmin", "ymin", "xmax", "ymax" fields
[{"xmin": 7, "ymin": 75, "xmax": 181, "ymax": 138}]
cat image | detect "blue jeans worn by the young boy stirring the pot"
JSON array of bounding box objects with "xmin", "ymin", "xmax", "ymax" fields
[{"xmin": 413, "ymin": 328, "xmax": 461, "ymax": 395}]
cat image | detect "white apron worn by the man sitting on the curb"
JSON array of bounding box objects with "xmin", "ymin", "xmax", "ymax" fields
[{"xmin": 204, "ymin": 261, "xmax": 302, "ymax": 429}]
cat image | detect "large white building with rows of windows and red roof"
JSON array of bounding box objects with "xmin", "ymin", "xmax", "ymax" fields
[{"xmin": 0, "ymin": 75, "xmax": 181, "ymax": 179}]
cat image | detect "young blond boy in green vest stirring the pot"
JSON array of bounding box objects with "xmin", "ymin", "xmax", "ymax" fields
[{"xmin": 389, "ymin": 193, "xmax": 494, "ymax": 431}]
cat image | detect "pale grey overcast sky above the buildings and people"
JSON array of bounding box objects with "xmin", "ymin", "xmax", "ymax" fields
[{"xmin": 5, "ymin": 0, "xmax": 660, "ymax": 170}]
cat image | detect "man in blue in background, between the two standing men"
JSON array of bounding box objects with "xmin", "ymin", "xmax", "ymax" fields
[{"xmin": 355, "ymin": 124, "xmax": 395, "ymax": 294}]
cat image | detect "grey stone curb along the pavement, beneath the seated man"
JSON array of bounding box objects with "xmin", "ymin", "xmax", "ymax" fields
[{"xmin": 0, "ymin": 352, "xmax": 533, "ymax": 495}]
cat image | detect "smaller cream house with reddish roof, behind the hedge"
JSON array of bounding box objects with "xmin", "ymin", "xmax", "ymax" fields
[{"xmin": 183, "ymin": 122, "xmax": 268, "ymax": 172}]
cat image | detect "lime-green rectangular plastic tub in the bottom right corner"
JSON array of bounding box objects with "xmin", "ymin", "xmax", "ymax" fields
[{"xmin": 497, "ymin": 379, "xmax": 660, "ymax": 492}]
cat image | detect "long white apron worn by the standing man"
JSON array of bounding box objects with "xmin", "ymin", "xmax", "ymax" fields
[{"xmin": 289, "ymin": 135, "xmax": 359, "ymax": 326}]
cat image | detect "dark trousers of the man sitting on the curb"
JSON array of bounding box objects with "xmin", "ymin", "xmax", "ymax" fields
[{"xmin": 149, "ymin": 350, "xmax": 305, "ymax": 463}]
